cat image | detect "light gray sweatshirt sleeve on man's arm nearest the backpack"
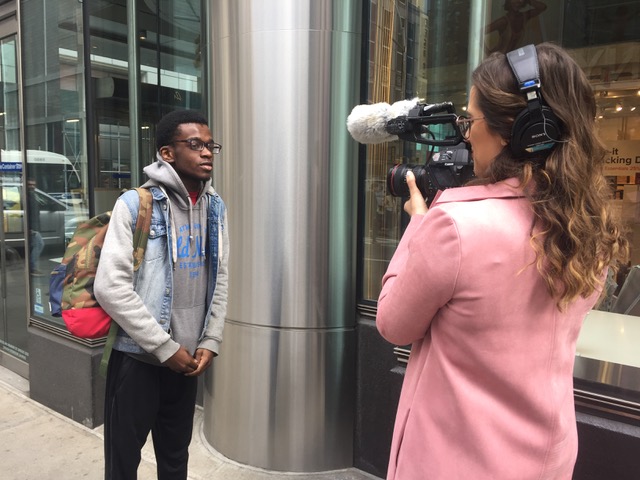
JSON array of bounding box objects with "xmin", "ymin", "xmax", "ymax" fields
[{"xmin": 94, "ymin": 200, "xmax": 180, "ymax": 362}]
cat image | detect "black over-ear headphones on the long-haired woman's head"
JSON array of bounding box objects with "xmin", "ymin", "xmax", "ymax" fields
[{"xmin": 507, "ymin": 45, "xmax": 562, "ymax": 157}]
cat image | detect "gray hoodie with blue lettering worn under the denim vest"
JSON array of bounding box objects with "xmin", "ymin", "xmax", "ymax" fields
[{"xmin": 95, "ymin": 157, "xmax": 229, "ymax": 363}]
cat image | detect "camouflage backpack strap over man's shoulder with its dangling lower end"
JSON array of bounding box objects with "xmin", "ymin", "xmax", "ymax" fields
[{"xmin": 99, "ymin": 187, "xmax": 153, "ymax": 378}]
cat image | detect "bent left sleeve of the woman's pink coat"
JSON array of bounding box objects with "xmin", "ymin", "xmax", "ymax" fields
[{"xmin": 376, "ymin": 207, "xmax": 460, "ymax": 345}]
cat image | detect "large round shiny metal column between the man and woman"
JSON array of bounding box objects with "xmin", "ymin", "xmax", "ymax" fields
[{"xmin": 204, "ymin": 0, "xmax": 362, "ymax": 472}]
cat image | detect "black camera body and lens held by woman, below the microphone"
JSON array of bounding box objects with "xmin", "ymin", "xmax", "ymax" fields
[{"xmin": 387, "ymin": 146, "xmax": 474, "ymax": 205}]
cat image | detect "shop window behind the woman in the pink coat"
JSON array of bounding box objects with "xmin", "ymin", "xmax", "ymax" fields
[{"xmin": 360, "ymin": 0, "xmax": 640, "ymax": 417}]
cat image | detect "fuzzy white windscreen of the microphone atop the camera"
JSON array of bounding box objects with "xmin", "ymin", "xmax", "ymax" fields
[{"xmin": 347, "ymin": 97, "xmax": 419, "ymax": 143}]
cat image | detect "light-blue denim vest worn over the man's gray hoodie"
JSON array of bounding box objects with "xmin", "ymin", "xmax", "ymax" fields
[{"xmin": 114, "ymin": 187, "xmax": 226, "ymax": 354}]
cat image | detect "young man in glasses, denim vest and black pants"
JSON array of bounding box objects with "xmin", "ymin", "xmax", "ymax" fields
[{"xmin": 95, "ymin": 111, "xmax": 229, "ymax": 480}]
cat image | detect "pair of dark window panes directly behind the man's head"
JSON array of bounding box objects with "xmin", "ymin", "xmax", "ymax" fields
[{"xmin": 91, "ymin": 0, "xmax": 206, "ymax": 195}]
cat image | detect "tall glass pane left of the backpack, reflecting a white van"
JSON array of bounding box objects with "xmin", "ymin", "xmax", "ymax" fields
[{"xmin": 21, "ymin": 0, "xmax": 89, "ymax": 327}]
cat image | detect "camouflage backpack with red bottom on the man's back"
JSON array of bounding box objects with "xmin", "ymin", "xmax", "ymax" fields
[{"xmin": 49, "ymin": 188, "xmax": 153, "ymax": 338}]
